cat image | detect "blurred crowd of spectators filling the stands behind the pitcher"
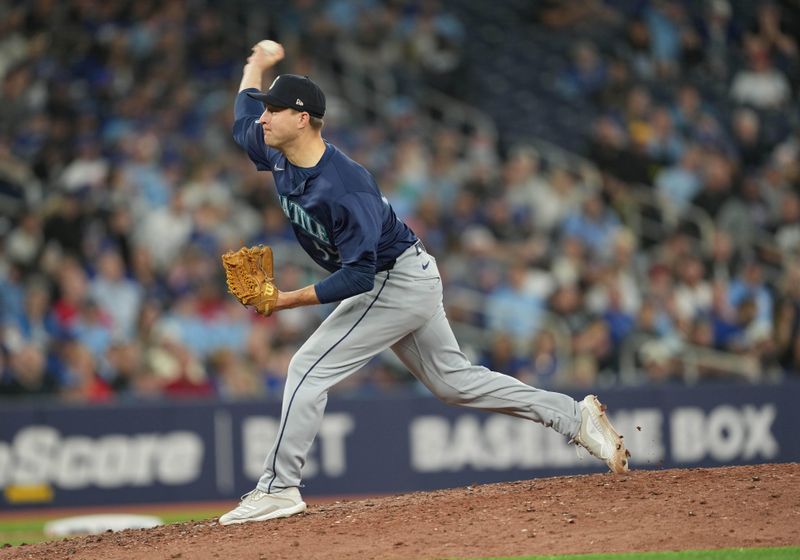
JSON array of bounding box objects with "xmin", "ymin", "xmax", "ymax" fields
[{"xmin": 0, "ymin": 0, "xmax": 800, "ymax": 402}]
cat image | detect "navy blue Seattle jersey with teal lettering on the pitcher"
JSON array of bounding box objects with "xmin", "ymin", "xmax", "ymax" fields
[{"xmin": 233, "ymin": 89, "xmax": 417, "ymax": 299}]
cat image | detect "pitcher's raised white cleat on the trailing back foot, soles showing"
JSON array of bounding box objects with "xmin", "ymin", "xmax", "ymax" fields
[{"xmin": 573, "ymin": 395, "xmax": 631, "ymax": 473}]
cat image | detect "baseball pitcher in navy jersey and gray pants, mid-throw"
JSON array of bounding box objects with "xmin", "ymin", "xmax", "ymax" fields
[{"xmin": 219, "ymin": 41, "xmax": 628, "ymax": 525}]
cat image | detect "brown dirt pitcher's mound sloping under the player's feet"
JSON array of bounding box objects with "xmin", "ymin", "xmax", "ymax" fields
[{"xmin": 0, "ymin": 463, "xmax": 800, "ymax": 560}]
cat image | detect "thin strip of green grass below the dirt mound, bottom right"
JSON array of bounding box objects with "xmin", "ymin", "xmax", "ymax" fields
[{"xmin": 483, "ymin": 547, "xmax": 800, "ymax": 560}]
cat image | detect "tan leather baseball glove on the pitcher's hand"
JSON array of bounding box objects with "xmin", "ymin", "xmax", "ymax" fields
[{"xmin": 222, "ymin": 245, "xmax": 278, "ymax": 315}]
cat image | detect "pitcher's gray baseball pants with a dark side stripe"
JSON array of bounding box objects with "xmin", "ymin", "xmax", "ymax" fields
[{"xmin": 258, "ymin": 243, "xmax": 580, "ymax": 492}]
